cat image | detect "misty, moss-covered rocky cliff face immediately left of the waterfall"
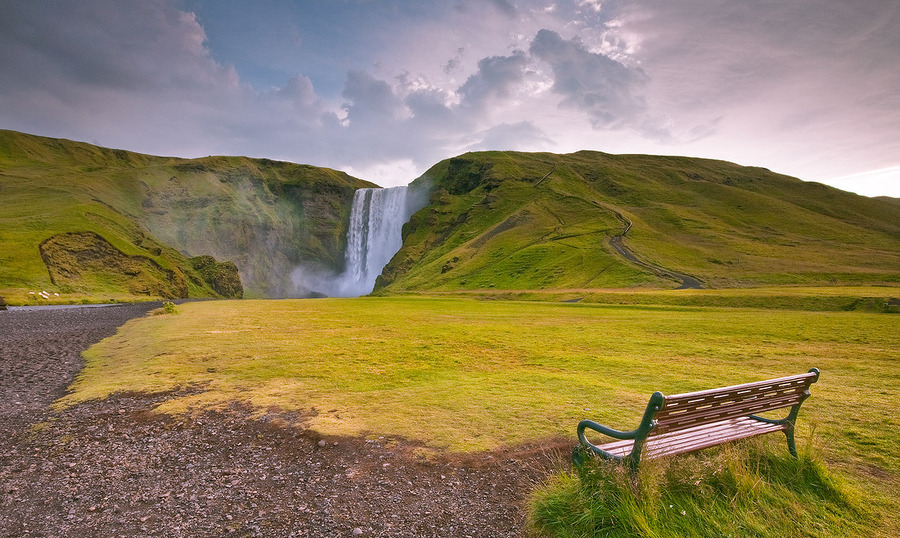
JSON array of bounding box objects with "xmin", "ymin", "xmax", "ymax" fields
[{"xmin": 138, "ymin": 157, "xmax": 371, "ymax": 297}]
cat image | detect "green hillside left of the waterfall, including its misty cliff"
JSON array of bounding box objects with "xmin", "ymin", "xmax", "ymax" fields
[{"xmin": 0, "ymin": 127, "xmax": 371, "ymax": 302}]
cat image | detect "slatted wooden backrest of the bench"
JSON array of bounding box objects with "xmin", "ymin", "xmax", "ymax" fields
[{"xmin": 650, "ymin": 371, "xmax": 819, "ymax": 436}]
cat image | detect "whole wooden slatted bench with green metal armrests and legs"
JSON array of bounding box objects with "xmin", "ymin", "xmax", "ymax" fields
[{"xmin": 572, "ymin": 368, "xmax": 819, "ymax": 471}]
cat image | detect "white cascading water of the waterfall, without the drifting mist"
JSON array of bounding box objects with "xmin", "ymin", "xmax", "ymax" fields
[{"xmin": 338, "ymin": 187, "xmax": 410, "ymax": 297}]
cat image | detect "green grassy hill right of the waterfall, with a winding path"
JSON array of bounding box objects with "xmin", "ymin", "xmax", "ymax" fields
[{"xmin": 379, "ymin": 151, "xmax": 900, "ymax": 292}]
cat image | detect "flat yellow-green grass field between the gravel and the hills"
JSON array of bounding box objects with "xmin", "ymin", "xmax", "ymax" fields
[{"xmin": 61, "ymin": 297, "xmax": 900, "ymax": 535}]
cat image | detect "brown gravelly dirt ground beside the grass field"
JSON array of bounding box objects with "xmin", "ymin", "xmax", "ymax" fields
[{"xmin": 0, "ymin": 305, "xmax": 570, "ymax": 537}]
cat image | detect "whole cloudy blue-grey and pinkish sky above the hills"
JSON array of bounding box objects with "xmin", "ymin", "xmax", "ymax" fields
[{"xmin": 0, "ymin": 0, "xmax": 900, "ymax": 197}]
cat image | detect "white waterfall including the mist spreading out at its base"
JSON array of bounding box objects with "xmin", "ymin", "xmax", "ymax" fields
[{"xmin": 292, "ymin": 182, "xmax": 425, "ymax": 297}]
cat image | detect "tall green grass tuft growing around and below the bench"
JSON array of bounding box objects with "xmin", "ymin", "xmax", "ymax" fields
[{"xmin": 530, "ymin": 439, "xmax": 874, "ymax": 538}]
